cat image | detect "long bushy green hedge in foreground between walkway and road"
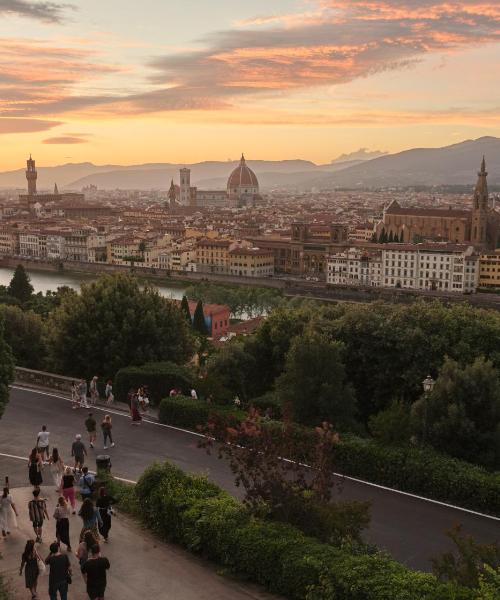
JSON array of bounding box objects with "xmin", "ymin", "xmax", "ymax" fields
[{"xmin": 106, "ymin": 463, "xmax": 475, "ymax": 600}]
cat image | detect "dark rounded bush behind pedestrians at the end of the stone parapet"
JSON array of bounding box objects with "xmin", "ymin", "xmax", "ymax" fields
[{"xmin": 113, "ymin": 362, "xmax": 194, "ymax": 406}]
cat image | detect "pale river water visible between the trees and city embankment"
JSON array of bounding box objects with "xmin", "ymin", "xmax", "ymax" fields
[{"xmin": 0, "ymin": 267, "xmax": 185, "ymax": 300}]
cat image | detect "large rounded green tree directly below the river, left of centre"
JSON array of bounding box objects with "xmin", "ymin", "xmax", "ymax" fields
[{"xmin": 47, "ymin": 275, "xmax": 194, "ymax": 377}]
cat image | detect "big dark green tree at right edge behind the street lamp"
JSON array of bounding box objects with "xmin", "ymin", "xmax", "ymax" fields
[{"xmin": 413, "ymin": 358, "xmax": 500, "ymax": 467}]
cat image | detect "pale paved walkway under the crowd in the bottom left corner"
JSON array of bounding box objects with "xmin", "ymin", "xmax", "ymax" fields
[{"xmin": 0, "ymin": 487, "xmax": 276, "ymax": 600}]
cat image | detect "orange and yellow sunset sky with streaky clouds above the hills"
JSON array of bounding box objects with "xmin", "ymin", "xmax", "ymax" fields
[{"xmin": 0, "ymin": 0, "xmax": 500, "ymax": 170}]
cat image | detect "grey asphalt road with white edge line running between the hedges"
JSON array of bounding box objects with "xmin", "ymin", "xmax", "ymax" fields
[{"xmin": 0, "ymin": 389, "xmax": 500, "ymax": 570}]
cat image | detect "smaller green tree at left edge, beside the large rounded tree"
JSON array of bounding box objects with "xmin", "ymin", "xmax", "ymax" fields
[{"xmin": 0, "ymin": 305, "xmax": 47, "ymax": 369}]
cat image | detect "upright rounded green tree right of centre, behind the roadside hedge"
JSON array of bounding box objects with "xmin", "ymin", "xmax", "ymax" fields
[{"xmin": 276, "ymin": 332, "xmax": 356, "ymax": 428}]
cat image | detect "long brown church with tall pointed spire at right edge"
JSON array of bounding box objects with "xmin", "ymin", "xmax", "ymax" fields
[{"xmin": 376, "ymin": 157, "xmax": 500, "ymax": 248}]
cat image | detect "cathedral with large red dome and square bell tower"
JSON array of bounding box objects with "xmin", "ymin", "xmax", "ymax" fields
[{"xmin": 168, "ymin": 154, "xmax": 261, "ymax": 208}]
